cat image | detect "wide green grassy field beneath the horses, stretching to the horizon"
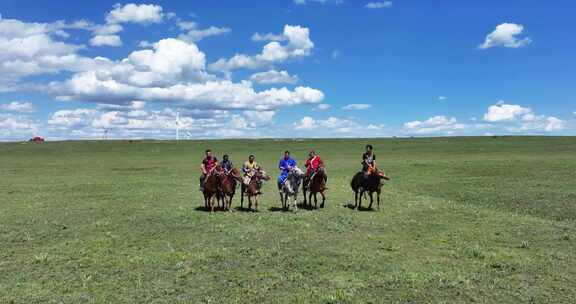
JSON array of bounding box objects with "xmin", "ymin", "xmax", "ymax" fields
[{"xmin": 0, "ymin": 137, "xmax": 576, "ymax": 303}]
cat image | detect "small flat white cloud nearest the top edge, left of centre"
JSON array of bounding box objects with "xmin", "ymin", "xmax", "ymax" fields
[{"xmin": 106, "ymin": 3, "xmax": 164, "ymax": 24}]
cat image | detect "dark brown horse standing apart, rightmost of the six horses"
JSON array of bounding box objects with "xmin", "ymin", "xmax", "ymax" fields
[{"xmin": 350, "ymin": 167, "xmax": 390, "ymax": 210}]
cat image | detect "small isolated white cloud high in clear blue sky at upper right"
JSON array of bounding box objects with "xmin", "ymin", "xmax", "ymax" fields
[{"xmin": 478, "ymin": 23, "xmax": 532, "ymax": 50}]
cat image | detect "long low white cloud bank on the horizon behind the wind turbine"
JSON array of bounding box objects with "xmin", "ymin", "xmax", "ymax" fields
[{"xmin": 46, "ymin": 102, "xmax": 276, "ymax": 138}]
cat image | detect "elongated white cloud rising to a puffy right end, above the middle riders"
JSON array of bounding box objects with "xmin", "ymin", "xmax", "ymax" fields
[{"xmin": 209, "ymin": 25, "xmax": 314, "ymax": 72}]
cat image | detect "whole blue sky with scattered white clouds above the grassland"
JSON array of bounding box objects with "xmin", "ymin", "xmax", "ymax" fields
[{"xmin": 0, "ymin": 0, "xmax": 576, "ymax": 141}]
